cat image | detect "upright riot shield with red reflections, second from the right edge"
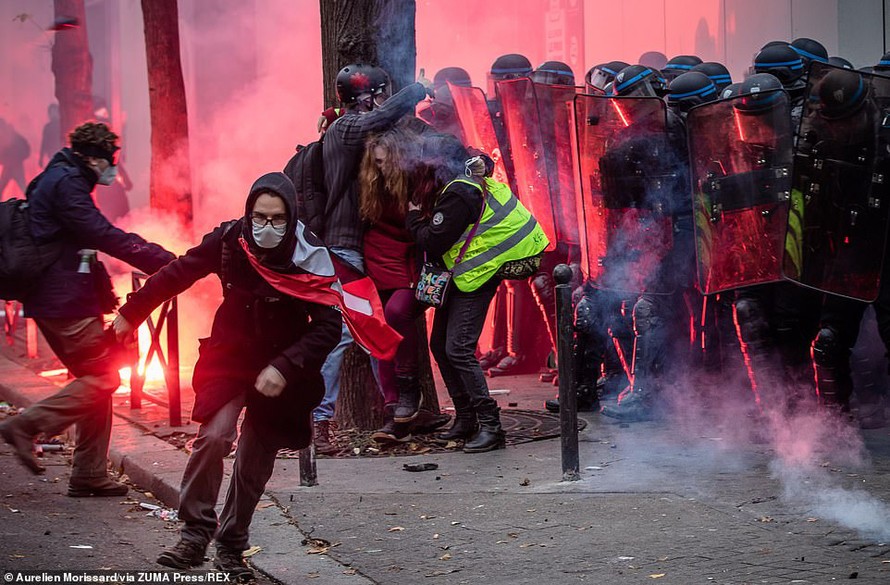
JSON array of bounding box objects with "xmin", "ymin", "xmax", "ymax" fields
[{"xmin": 686, "ymin": 90, "xmax": 792, "ymax": 295}]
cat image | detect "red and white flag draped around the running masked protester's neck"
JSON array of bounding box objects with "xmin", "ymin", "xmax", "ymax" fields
[{"xmin": 240, "ymin": 228, "xmax": 402, "ymax": 360}]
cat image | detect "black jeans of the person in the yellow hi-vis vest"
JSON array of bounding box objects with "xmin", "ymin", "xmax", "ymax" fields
[{"xmin": 430, "ymin": 279, "xmax": 499, "ymax": 414}]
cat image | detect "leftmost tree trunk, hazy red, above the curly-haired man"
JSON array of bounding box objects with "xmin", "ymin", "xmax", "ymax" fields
[{"xmin": 52, "ymin": 0, "xmax": 93, "ymax": 144}]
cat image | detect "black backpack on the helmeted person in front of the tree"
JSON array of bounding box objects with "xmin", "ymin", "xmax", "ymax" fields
[{"xmin": 283, "ymin": 140, "xmax": 328, "ymax": 239}]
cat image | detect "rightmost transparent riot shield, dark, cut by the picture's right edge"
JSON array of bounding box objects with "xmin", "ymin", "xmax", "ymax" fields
[{"xmin": 783, "ymin": 63, "xmax": 890, "ymax": 302}]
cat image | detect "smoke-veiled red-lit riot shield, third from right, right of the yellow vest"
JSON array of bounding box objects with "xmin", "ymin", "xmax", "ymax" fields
[{"xmin": 573, "ymin": 95, "xmax": 676, "ymax": 293}]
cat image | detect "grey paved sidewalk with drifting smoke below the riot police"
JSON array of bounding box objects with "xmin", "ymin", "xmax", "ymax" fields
[{"xmin": 0, "ymin": 356, "xmax": 890, "ymax": 585}]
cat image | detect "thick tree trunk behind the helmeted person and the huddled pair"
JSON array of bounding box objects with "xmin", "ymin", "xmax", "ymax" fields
[{"xmin": 319, "ymin": 0, "xmax": 439, "ymax": 430}]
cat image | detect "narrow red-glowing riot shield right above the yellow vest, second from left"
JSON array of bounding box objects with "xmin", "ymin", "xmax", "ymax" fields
[{"xmin": 497, "ymin": 78, "xmax": 557, "ymax": 251}]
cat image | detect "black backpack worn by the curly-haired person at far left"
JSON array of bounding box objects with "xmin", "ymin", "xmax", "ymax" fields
[{"xmin": 0, "ymin": 173, "xmax": 62, "ymax": 301}]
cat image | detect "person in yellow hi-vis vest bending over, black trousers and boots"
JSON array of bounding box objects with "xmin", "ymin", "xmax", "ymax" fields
[{"xmin": 406, "ymin": 154, "xmax": 549, "ymax": 453}]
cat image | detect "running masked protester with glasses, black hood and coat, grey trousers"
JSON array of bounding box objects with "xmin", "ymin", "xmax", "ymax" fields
[{"xmin": 114, "ymin": 173, "xmax": 341, "ymax": 580}]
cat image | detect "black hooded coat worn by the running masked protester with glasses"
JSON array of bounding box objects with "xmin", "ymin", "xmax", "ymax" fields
[{"xmin": 120, "ymin": 173, "xmax": 341, "ymax": 448}]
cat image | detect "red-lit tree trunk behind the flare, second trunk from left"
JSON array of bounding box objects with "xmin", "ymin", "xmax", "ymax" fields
[{"xmin": 142, "ymin": 0, "xmax": 192, "ymax": 227}]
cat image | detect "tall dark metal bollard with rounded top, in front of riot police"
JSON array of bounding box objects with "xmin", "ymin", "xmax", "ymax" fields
[{"xmin": 553, "ymin": 264, "xmax": 581, "ymax": 481}]
